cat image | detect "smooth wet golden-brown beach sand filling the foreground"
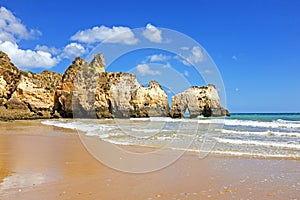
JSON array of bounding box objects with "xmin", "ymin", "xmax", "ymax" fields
[{"xmin": 0, "ymin": 121, "xmax": 300, "ymax": 200}]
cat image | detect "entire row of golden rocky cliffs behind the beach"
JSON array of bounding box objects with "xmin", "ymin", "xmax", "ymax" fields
[{"xmin": 0, "ymin": 52, "xmax": 229, "ymax": 119}]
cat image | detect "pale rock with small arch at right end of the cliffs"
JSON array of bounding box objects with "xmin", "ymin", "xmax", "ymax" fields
[{"xmin": 170, "ymin": 84, "xmax": 229, "ymax": 118}]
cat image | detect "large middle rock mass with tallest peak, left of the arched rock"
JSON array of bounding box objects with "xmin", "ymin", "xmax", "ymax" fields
[{"xmin": 54, "ymin": 55, "xmax": 169, "ymax": 118}]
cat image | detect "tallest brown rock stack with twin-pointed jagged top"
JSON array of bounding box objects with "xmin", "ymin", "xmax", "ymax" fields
[{"xmin": 54, "ymin": 54, "xmax": 111, "ymax": 118}]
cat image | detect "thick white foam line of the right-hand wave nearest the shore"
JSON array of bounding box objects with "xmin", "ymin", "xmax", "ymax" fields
[{"xmin": 214, "ymin": 137, "xmax": 300, "ymax": 149}]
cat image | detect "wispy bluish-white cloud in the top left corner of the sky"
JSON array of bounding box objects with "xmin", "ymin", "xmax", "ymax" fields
[{"xmin": 0, "ymin": 7, "xmax": 41, "ymax": 42}]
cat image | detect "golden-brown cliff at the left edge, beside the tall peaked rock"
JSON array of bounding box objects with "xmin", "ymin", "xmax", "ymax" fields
[{"xmin": 0, "ymin": 52, "xmax": 62, "ymax": 119}]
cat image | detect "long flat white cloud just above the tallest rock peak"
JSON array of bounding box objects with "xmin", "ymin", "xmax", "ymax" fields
[{"xmin": 71, "ymin": 26, "xmax": 138, "ymax": 45}]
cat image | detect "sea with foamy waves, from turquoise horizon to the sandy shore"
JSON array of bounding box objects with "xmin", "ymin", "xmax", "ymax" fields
[{"xmin": 42, "ymin": 113, "xmax": 300, "ymax": 159}]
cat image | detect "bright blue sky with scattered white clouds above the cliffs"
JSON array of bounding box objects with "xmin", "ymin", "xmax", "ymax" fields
[{"xmin": 0, "ymin": 0, "xmax": 300, "ymax": 112}]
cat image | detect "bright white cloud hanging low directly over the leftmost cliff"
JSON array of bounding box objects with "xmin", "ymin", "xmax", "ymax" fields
[{"xmin": 0, "ymin": 41, "xmax": 60, "ymax": 69}]
